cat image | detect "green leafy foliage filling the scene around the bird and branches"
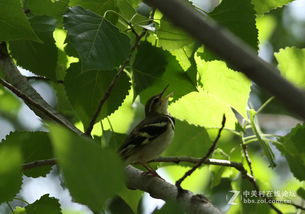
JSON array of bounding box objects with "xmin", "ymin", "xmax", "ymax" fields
[{"xmin": 0, "ymin": 0, "xmax": 305, "ymax": 214}]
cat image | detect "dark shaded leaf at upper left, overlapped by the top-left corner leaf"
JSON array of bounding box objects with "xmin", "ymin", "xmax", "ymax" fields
[{"xmin": 10, "ymin": 16, "xmax": 57, "ymax": 80}]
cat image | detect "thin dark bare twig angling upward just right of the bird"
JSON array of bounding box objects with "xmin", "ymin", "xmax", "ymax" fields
[{"xmin": 176, "ymin": 115, "xmax": 226, "ymax": 190}]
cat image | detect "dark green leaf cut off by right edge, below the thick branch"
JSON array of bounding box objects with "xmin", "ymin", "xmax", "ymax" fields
[{"xmin": 275, "ymin": 125, "xmax": 305, "ymax": 181}]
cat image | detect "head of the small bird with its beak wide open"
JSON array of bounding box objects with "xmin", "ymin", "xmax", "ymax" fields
[{"xmin": 145, "ymin": 85, "xmax": 173, "ymax": 116}]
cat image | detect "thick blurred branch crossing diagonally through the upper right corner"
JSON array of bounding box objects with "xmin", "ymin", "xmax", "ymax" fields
[{"xmin": 144, "ymin": 0, "xmax": 305, "ymax": 119}]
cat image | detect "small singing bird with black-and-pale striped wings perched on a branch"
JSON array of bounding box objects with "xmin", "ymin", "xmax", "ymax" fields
[{"xmin": 119, "ymin": 86, "xmax": 175, "ymax": 174}]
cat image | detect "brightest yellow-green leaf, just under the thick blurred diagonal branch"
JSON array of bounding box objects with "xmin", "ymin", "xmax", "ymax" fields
[{"xmin": 195, "ymin": 57, "xmax": 251, "ymax": 118}]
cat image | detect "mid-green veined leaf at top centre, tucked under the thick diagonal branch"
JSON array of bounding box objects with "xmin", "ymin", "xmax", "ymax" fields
[{"xmin": 157, "ymin": 16, "xmax": 194, "ymax": 50}]
